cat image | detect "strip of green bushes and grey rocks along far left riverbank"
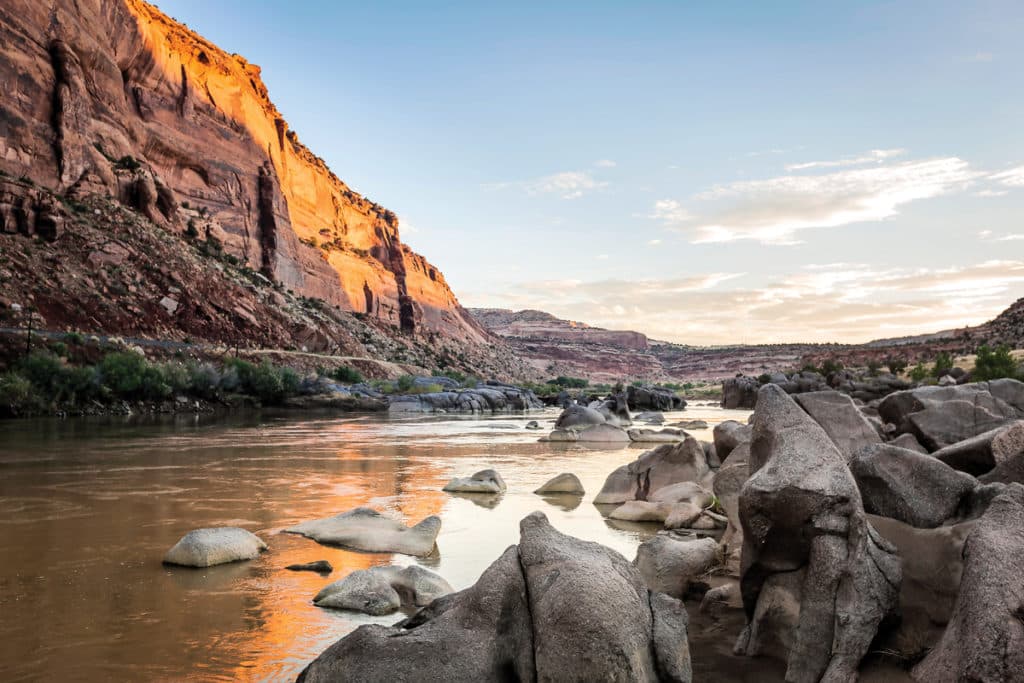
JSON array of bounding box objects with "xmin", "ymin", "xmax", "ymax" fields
[{"xmin": 0, "ymin": 333, "xmax": 543, "ymax": 418}]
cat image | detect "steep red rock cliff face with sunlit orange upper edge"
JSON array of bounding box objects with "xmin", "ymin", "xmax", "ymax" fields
[{"xmin": 0, "ymin": 0, "xmax": 487, "ymax": 342}]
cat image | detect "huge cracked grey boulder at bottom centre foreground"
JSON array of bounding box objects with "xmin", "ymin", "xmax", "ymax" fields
[{"xmin": 298, "ymin": 512, "xmax": 691, "ymax": 683}]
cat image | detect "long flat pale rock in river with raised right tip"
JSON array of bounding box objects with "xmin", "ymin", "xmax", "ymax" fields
[{"xmin": 285, "ymin": 508, "xmax": 441, "ymax": 556}]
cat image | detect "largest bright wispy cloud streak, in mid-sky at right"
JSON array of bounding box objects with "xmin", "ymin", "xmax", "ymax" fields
[{"xmin": 649, "ymin": 151, "xmax": 984, "ymax": 245}]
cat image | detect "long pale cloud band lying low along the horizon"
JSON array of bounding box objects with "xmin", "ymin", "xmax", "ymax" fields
[{"xmin": 462, "ymin": 261, "xmax": 1024, "ymax": 345}]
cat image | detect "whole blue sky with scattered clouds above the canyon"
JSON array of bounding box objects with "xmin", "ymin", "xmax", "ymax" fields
[{"xmin": 157, "ymin": 0, "xmax": 1024, "ymax": 345}]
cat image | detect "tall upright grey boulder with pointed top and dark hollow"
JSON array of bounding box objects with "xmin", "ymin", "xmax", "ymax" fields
[{"xmin": 736, "ymin": 384, "xmax": 900, "ymax": 683}]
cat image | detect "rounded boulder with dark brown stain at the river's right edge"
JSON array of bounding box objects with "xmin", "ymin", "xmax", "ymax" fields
[{"xmin": 594, "ymin": 436, "xmax": 710, "ymax": 505}]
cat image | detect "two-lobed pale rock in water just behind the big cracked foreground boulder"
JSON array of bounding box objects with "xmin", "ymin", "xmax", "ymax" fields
[{"xmin": 313, "ymin": 564, "xmax": 452, "ymax": 616}]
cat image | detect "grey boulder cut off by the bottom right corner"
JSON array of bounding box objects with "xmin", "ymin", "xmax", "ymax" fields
[{"xmin": 912, "ymin": 484, "xmax": 1024, "ymax": 683}]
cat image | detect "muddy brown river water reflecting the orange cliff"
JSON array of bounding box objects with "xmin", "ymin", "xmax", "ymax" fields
[{"xmin": 0, "ymin": 405, "xmax": 901, "ymax": 681}]
